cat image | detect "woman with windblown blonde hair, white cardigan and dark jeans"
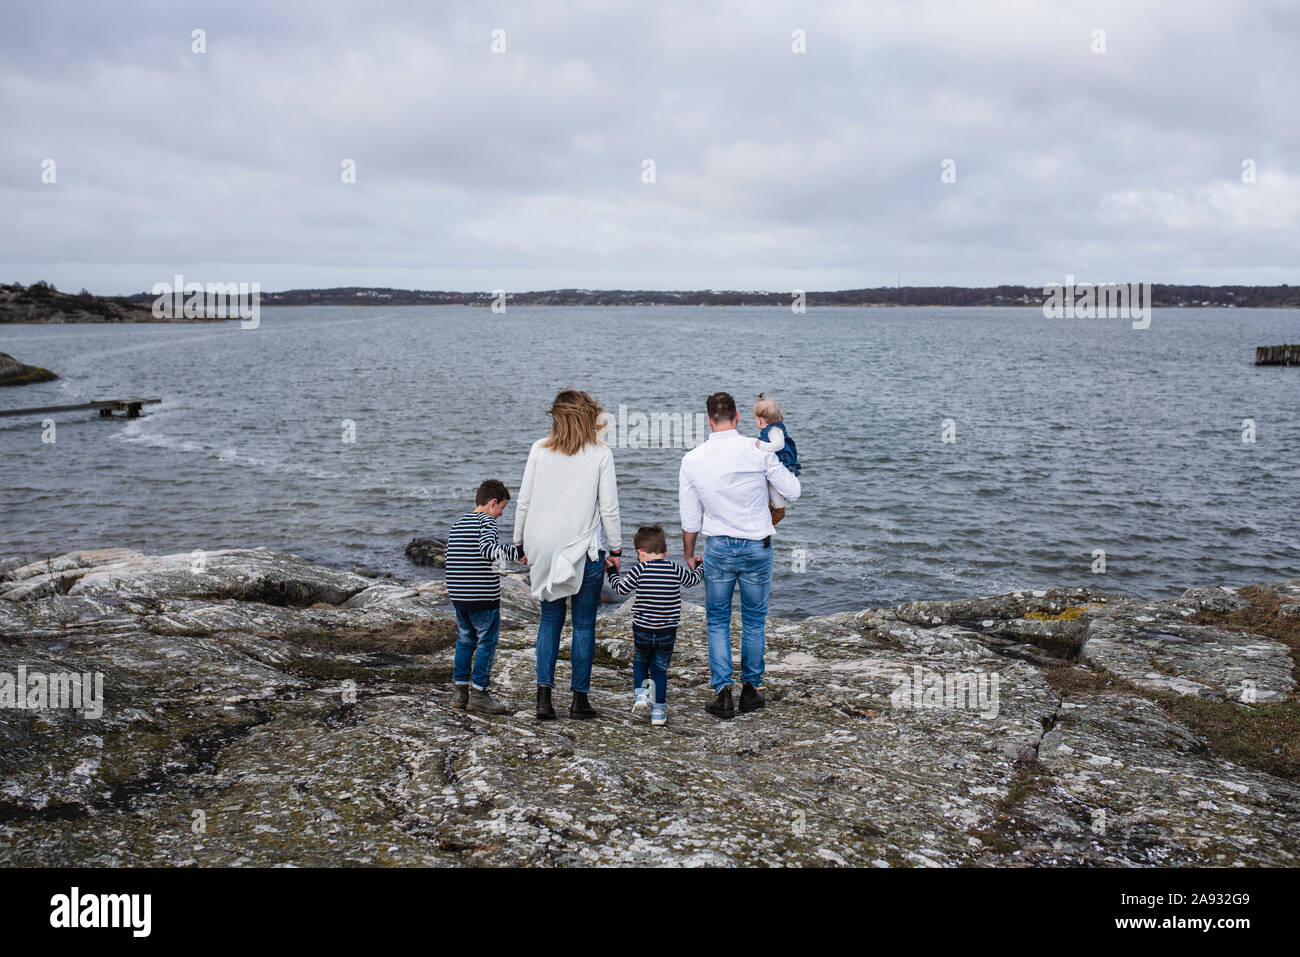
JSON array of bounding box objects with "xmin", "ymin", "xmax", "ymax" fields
[{"xmin": 515, "ymin": 389, "xmax": 623, "ymax": 720}]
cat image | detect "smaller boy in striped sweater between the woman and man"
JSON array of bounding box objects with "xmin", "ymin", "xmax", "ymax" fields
[{"xmin": 608, "ymin": 525, "xmax": 705, "ymax": 726}]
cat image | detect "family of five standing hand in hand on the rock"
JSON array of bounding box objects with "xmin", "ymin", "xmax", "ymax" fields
[{"xmin": 447, "ymin": 389, "xmax": 801, "ymax": 726}]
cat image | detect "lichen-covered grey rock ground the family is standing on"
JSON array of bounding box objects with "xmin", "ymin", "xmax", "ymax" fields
[{"xmin": 0, "ymin": 549, "xmax": 1300, "ymax": 866}]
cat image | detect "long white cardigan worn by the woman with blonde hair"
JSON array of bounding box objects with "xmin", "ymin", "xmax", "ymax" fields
[{"xmin": 515, "ymin": 438, "xmax": 623, "ymax": 602}]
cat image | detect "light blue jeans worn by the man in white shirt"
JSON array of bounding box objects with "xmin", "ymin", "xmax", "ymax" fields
[{"xmin": 705, "ymin": 536, "xmax": 772, "ymax": 692}]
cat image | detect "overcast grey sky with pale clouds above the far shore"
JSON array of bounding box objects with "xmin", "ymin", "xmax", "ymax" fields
[{"xmin": 0, "ymin": 0, "xmax": 1300, "ymax": 294}]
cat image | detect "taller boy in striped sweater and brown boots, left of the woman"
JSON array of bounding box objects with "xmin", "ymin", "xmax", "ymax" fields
[{"xmin": 447, "ymin": 479, "xmax": 528, "ymax": 714}]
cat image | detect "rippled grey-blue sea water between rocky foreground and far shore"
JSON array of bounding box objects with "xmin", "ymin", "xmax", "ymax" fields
[{"xmin": 0, "ymin": 307, "xmax": 1300, "ymax": 615}]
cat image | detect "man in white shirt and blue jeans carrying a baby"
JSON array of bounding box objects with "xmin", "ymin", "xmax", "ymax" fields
[{"xmin": 679, "ymin": 393, "xmax": 801, "ymax": 719}]
